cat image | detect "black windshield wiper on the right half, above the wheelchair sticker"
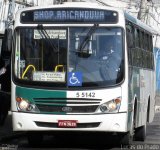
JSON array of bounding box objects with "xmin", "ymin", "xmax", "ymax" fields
[{"xmin": 78, "ymin": 24, "xmax": 99, "ymax": 52}]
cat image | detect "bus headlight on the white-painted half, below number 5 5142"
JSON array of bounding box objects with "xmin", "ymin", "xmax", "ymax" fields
[{"xmin": 99, "ymin": 97, "xmax": 121, "ymax": 113}]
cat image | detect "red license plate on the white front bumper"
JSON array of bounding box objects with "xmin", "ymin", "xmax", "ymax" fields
[{"xmin": 58, "ymin": 120, "xmax": 77, "ymax": 128}]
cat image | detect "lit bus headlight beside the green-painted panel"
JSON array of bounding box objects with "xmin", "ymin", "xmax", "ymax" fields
[{"xmin": 16, "ymin": 97, "xmax": 39, "ymax": 112}]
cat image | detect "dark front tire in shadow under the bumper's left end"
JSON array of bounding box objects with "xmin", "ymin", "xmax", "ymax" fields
[{"xmin": 27, "ymin": 132, "xmax": 43, "ymax": 147}]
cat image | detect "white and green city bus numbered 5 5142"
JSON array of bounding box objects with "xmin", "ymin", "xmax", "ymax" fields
[{"xmin": 12, "ymin": 2, "xmax": 155, "ymax": 144}]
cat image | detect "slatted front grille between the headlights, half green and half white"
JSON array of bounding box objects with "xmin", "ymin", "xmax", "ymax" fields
[{"xmin": 34, "ymin": 98, "xmax": 101, "ymax": 114}]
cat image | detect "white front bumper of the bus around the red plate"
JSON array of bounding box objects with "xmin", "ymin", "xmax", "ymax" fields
[{"xmin": 12, "ymin": 112, "xmax": 127, "ymax": 132}]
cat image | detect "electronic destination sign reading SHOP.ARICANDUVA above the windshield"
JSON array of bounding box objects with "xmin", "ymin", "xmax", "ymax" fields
[{"xmin": 21, "ymin": 8, "xmax": 118, "ymax": 23}]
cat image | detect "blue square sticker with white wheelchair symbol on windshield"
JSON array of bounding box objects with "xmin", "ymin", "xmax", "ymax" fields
[{"xmin": 68, "ymin": 72, "xmax": 82, "ymax": 86}]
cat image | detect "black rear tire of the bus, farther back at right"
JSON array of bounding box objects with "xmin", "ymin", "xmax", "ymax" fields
[{"xmin": 135, "ymin": 124, "xmax": 146, "ymax": 141}]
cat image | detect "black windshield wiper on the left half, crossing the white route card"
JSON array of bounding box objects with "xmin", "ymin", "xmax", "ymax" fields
[{"xmin": 37, "ymin": 24, "xmax": 58, "ymax": 52}]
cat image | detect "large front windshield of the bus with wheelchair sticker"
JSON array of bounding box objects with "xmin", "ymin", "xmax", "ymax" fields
[{"xmin": 14, "ymin": 26, "xmax": 124, "ymax": 88}]
